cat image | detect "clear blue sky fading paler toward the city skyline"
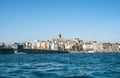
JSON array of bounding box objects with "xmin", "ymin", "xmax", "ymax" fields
[{"xmin": 0, "ymin": 0, "xmax": 120, "ymax": 42}]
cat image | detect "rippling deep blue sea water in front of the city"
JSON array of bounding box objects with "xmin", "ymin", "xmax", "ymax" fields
[{"xmin": 0, "ymin": 53, "xmax": 120, "ymax": 78}]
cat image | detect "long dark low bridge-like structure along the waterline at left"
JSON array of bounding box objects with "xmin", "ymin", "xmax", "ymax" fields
[{"xmin": 0, "ymin": 48, "xmax": 69, "ymax": 54}]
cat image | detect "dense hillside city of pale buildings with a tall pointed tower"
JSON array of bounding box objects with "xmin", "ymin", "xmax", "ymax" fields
[{"xmin": 0, "ymin": 33, "xmax": 120, "ymax": 53}]
